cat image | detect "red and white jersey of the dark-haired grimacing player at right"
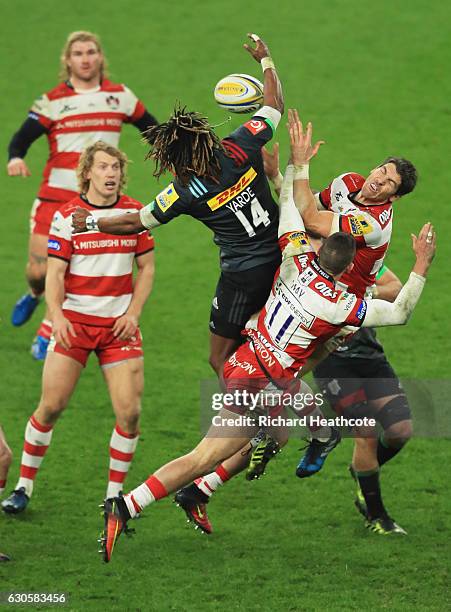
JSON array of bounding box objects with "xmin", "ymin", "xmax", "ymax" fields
[{"xmin": 319, "ymin": 172, "xmax": 393, "ymax": 297}]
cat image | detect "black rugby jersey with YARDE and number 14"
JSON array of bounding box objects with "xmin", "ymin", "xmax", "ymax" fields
[{"xmin": 149, "ymin": 113, "xmax": 280, "ymax": 272}]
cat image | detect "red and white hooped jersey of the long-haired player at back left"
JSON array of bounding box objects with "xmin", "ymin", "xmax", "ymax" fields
[{"xmin": 29, "ymin": 79, "xmax": 145, "ymax": 202}]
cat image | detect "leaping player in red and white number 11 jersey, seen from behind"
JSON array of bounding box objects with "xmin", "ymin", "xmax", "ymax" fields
[{"xmin": 101, "ymin": 147, "xmax": 435, "ymax": 561}]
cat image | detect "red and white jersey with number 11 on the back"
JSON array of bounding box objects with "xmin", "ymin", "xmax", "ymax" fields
[{"xmin": 243, "ymin": 232, "xmax": 367, "ymax": 380}]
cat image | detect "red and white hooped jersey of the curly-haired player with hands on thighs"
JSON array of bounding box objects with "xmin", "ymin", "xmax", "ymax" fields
[{"xmin": 48, "ymin": 195, "xmax": 154, "ymax": 327}]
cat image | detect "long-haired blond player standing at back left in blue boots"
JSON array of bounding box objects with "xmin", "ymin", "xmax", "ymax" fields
[{"xmin": 7, "ymin": 32, "xmax": 157, "ymax": 359}]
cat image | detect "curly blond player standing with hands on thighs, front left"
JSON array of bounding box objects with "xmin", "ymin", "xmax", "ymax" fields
[{"xmin": 2, "ymin": 141, "xmax": 154, "ymax": 514}]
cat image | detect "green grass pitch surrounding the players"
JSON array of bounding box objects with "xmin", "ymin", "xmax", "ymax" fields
[{"xmin": 0, "ymin": 0, "xmax": 451, "ymax": 611}]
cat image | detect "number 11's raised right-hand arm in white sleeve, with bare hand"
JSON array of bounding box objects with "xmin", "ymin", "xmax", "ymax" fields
[{"xmin": 363, "ymin": 223, "xmax": 436, "ymax": 327}]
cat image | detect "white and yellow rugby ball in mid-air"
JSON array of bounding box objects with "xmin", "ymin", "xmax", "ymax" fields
[{"xmin": 214, "ymin": 74, "xmax": 263, "ymax": 113}]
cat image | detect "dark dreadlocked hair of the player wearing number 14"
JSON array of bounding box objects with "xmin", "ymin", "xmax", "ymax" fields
[{"xmin": 143, "ymin": 106, "xmax": 225, "ymax": 185}]
